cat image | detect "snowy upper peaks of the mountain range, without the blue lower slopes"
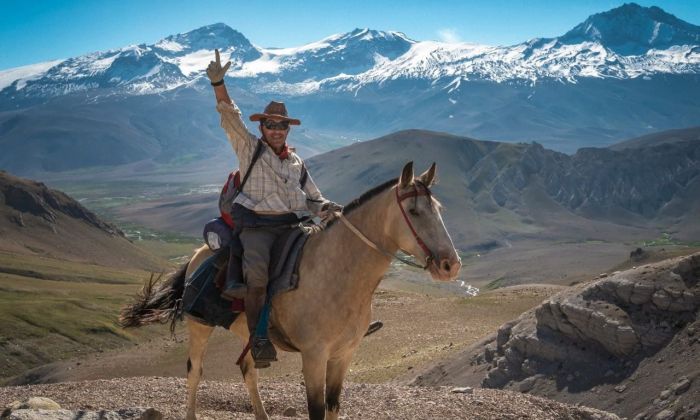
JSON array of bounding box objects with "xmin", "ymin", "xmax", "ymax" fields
[{"xmin": 0, "ymin": 4, "xmax": 700, "ymax": 98}]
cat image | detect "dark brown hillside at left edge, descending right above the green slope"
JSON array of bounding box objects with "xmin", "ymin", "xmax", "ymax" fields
[{"xmin": 0, "ymin": 171, "xmax": 162, "ymax": 270}]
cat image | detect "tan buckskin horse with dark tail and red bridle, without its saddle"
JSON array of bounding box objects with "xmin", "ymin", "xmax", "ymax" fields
[{"xmin": 120, "ymin": 162, "xmax": 461, "ymax": 420}]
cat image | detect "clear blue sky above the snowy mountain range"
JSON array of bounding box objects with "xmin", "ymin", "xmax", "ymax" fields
[{"xmin": 0, "ymin": 0, "xmax": 700, "ymax": 70}]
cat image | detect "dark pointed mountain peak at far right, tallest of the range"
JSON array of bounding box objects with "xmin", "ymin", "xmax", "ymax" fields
[{"xmin": 559, "ymin": 3, "xmax": 700, "ymax": 55}]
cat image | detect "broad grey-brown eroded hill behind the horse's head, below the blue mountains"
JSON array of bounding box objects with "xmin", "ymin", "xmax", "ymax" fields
[{"xmin": 308, "ymin": 130, "xmax": 700, "ymax": 246}]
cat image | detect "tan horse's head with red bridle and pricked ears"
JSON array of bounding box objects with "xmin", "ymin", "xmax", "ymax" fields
[{"xmin": 390, "ymin": 162, "xmax": 462, "ymax": 281}]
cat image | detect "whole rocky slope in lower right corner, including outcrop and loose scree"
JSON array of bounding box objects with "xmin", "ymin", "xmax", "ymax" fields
[{"xmin": 413, "ymin": 254, "xmax": 700, "ymax": 419}]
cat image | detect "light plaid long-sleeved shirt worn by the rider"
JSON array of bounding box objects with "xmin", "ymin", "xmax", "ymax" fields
[{"xmin": 216, "ymin": 101, "xmax": 327, "ymax": 216}]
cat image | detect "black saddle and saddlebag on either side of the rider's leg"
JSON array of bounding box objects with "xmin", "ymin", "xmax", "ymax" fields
[{"xmin": 181, "ymin": 227, "xmax": 311, "ymax": 329}]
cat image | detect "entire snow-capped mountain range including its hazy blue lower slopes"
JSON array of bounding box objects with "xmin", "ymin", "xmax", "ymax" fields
[{"xmin": 0, "ymin": 4, "xmax": 700, "ymax": 176}]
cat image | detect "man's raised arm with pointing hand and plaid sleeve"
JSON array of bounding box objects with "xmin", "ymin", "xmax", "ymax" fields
[{"xmin": 207, "ymin": 50, "xmax": 255, "ymax": 159}]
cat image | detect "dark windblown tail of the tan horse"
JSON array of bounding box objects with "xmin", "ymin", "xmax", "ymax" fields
[{"xmin": 119, "ymin": 262, "xmax": 189, "ymax": 333}]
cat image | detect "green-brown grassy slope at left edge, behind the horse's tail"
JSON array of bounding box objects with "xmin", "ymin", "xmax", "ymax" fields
[{"xmin": 0, "ymin": 253, "xmax": 171, "ymax": 381}]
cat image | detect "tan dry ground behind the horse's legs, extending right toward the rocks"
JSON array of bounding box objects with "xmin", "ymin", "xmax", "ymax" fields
[{"xmin": 19, "ymin": 271, "xmax": 559, "ymax": 383}]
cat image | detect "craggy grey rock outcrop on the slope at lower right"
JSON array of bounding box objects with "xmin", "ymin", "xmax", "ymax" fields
[{"xmin": 481, "ymin": 254, "xmax": 700, "ymax": 392}]
